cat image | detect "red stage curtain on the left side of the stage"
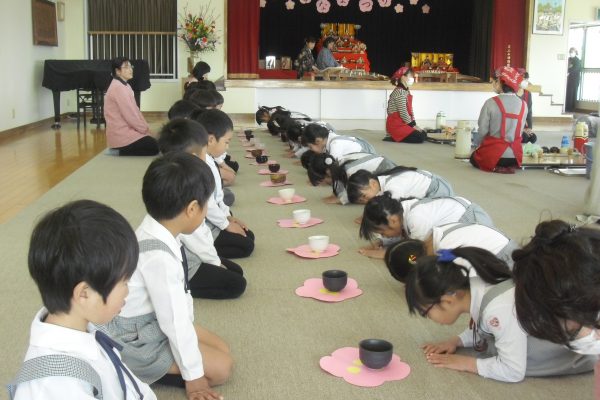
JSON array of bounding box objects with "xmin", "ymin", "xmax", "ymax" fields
[{"xmin": 227, "ymin": 0, "xmax": 260, "ymax": 79}]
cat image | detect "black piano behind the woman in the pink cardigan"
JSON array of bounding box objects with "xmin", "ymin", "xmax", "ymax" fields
[{"xmin": 42, "ymin": 60, "xmax": 150, "ymax": 129}]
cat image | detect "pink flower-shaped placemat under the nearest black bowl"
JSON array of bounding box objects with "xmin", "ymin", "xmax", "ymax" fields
[{"xmin": 319, "ymin": 347, "xmax": 410, "ymax": 387}]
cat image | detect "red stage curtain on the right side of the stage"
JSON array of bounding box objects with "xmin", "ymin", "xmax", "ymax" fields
[{"xmin": 491, "ymin": 0, "xmax": 526, "ymax": 69}]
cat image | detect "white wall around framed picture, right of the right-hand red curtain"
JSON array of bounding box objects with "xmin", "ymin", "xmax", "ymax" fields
[{"xmin": 527, "ymin": 0, "xmax": 600, "ymax": 104}]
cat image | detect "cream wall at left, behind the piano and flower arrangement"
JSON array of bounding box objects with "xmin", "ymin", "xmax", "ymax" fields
[{"xmin": 0, "ymin": 0, "xmax": 226, "ymax": 132}]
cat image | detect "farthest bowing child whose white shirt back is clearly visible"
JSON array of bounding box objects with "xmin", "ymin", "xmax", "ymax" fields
[{"xmin": 302, "ymin": 123, "xmax": 377, "ymax": 161}]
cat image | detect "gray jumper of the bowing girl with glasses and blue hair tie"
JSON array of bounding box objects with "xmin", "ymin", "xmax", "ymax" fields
[{"xmin": 477, "ymin": 279, "xmax": 597, "ymax": 376}]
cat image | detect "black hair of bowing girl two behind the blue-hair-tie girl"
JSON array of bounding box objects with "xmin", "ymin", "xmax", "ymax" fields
[{"xmin": 359, "ymin": 192, "xmax": 404, "ymax": 240}]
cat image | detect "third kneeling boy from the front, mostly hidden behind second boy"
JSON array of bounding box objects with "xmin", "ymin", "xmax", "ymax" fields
[{"xmin": 158, "ymin": 119, "xmax": 246, "ymax": 299}]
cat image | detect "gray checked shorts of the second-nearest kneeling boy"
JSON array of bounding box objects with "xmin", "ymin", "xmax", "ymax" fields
[{"xmin": 105, "ymin": 313, "xmax": 175, "ymax": 384}]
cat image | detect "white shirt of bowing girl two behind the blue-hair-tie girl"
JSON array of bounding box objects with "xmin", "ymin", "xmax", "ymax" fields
[{"xmin": 402, "ymin": 197, "xmax": 471, "ymax": 240}]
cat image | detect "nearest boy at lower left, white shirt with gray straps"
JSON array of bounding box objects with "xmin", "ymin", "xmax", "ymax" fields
[{"xmin": 9, "ymin": 200, "xmax": 156, "ymax": 400}]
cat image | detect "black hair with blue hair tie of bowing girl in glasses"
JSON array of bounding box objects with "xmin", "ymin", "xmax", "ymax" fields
[{"xmin": 405, "ymin": 247, "xmax": 512, "ymax": 314}]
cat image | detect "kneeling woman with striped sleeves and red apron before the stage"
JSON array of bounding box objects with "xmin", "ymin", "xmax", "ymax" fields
[{"xmin": 383, "ymin": 67, "xmax": 427, "ymax": 143}]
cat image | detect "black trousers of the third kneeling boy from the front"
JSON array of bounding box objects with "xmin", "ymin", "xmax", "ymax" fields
[{"xmin": 189, "ymin": 258, "xmax": 246, "ymax": 300}]
